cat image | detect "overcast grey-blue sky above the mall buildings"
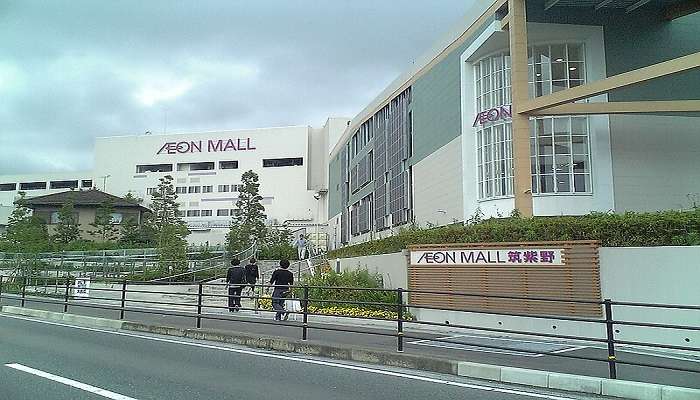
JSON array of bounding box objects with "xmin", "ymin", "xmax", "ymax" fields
[{"xmin": 0, "ymin": 0, "xmax": 471, "ymax": 174}]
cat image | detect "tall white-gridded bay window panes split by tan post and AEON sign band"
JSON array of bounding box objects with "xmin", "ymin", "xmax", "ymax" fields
[{"xmin": 474, "ymin": 44, "xmax": 591, "ymax": 199}]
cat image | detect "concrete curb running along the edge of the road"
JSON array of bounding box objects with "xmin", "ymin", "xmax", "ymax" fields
[{"xmin": 1, "ymin": 306, "xmax": 700, "ymax": 400}]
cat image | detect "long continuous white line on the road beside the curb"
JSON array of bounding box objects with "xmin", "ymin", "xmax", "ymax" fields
[{"xmin": 0, "ymin": 314, "xmax": 575, "ymax": 400}]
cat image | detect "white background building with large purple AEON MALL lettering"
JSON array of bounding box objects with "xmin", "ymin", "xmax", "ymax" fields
[{"xmin": 0, "ymin": 118, "xmax": 348, "ymax": 246}]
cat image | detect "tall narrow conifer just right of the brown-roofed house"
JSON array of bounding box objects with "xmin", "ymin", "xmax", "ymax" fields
[{"xmin": 148, "ymin": 175, "xmax": 189, "ymax": 273}]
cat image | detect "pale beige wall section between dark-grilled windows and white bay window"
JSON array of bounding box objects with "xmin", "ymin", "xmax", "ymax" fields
[{"xmin": 413, "ymin": 136, "xmax": 463, "ymax": 226}]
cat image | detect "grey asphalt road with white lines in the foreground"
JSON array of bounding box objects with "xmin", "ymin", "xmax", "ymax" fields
[{"xmin": 0, "ymin": 316, "xmax": 604, "ymax": 400}]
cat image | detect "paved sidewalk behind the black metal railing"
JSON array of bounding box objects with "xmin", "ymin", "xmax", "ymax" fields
[{"xmin": 2, "ymin": 292, "xmax": 700, "ymax": 388}]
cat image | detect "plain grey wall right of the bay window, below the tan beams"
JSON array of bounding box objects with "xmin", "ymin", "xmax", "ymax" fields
[{"xmin": 610, "ymin": 115, "xmax": 700, "ymax": 212}]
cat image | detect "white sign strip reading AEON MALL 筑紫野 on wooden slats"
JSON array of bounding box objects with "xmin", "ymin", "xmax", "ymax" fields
[{"xmin": 411, "ymin": 248, "xmax": 564, "ymax": 266}]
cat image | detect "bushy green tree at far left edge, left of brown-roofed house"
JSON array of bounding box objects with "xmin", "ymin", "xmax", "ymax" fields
[{"xmin": 4, "ymin": 192, "xmax": 49, "ymax": 252}]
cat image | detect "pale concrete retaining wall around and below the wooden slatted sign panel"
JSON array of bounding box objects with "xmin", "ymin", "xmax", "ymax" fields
[{"xmin": 341, "ymin": 246, "xmax": 700, "ymax": 351}]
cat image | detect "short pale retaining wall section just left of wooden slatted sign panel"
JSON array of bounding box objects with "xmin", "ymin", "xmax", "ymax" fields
[{"xmin": 338, "ymin": 252, "xmax": 408, "ymax": 289}]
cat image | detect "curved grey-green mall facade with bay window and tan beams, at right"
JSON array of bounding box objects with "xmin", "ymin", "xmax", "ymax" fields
[{"xmin": 329, "ymin": 0, "xmax": 700, "ymax": 247}]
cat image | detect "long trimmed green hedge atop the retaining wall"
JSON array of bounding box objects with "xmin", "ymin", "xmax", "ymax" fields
[{"xmin": 328, "ymin": 209, "xmax": 700, "ymax": 258}]
